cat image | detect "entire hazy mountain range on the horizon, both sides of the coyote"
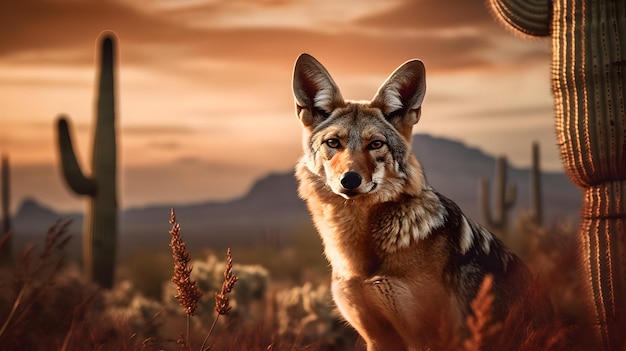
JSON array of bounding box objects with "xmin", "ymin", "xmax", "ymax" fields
[{"xmin": 7, "ymin": 135, "xmax": 581, "ymax": 258}]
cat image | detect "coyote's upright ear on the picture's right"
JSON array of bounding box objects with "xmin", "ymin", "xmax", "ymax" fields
[{"xmin": 370, "ymin": 60, "xmax": 426, "ymax": 140}]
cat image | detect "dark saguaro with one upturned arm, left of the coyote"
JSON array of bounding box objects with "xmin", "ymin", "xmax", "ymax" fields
[{"xmin": 58, "ymin": 33, "xmax": 117, "ymax": 288}]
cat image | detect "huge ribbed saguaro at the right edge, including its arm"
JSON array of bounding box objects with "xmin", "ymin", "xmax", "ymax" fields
[{"xmin": 490, "ymin": 0, "xmax": 626, "ymax": 350}]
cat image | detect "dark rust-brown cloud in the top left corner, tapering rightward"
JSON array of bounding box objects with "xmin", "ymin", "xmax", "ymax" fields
[{"xmin": 0, "ymin": 0, "xmax": 202, "ymax": 64}]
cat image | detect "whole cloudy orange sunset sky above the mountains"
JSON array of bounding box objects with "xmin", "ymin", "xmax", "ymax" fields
[{"xmin": 0, "ymin": 0, "xmax": 561, "ymax": 210}]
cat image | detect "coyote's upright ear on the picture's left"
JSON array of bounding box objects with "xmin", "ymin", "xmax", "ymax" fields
[{"xmin": 293, "ymin": 54, "xmax": 345, "ymax": 127}]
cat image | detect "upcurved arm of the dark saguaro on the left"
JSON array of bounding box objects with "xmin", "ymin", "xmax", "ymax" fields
[{"xmin": 57, "ymin": 117, "xmax": 96, "ymax": 196}]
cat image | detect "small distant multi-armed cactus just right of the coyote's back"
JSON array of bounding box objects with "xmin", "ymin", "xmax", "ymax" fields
[{"xmin": 479, "ymin": 157, "xmax": 517, "ymax": 235}]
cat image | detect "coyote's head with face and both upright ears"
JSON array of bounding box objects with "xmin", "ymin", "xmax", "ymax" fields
[{"xmin": 293, "ymin": 54, "xmax": 426, "ymax": 202}]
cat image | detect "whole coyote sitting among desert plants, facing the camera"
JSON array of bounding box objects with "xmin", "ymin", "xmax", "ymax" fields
[{"xmin": 293, "ymin": 54, "xmax": 530, "ymax": 351}]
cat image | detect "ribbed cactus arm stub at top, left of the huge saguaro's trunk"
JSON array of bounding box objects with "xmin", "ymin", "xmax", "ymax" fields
[{"xmin": 489, "ymin": 0, "xmax": 552, "ymax": 37}]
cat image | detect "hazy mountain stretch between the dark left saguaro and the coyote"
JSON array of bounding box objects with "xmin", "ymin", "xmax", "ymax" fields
[{"xmin": 116, "ymin": 172, "xmax": 311, "ymax": 252}]
